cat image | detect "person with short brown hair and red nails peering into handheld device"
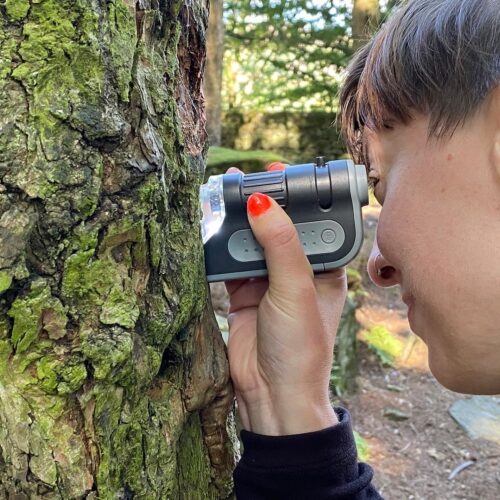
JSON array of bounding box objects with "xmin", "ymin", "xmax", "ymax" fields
[{"xmin": 227, "ymin": 0, "xmax": 500, "ymax": 499}]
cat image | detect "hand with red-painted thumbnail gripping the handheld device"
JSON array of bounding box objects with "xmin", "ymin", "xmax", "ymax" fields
[{"xmin": 226, "ymin": 166, "xmax": 347, "ymax": 435}]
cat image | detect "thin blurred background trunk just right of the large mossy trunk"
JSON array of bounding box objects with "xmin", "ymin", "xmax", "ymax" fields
[{"xmin": 204, "ymin": 0, "xmax": 224, "ymax": 146}]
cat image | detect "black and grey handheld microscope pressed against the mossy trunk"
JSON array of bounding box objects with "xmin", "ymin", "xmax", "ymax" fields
[{"xmin": 200, "ymin": 157, "xmax": 368, "ymax": 282}]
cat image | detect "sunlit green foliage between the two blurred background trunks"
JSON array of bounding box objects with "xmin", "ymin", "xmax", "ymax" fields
[{"xmin": 224, "ymin": 0, "xmax": 352, "ymax": 111}]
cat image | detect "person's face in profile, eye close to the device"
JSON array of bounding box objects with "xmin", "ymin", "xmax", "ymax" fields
[{"xmin": 367, "ymin": 89, "xmax": 500, "ymax": 394}]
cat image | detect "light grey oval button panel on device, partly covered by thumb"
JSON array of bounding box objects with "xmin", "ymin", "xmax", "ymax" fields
[{"xmin": 228, "ymin": 220, "xmax": 345, "ymax": 262}]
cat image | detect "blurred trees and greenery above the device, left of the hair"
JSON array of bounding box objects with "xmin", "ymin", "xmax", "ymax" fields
[{"xmin": 205, "ymin": 0, "xmax": 397, "ymax": 172}]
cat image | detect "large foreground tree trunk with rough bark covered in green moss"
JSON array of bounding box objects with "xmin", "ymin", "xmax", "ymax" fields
[{"xmin": 0, "ymin": 0, "xmax": 234, "ymax": 500}]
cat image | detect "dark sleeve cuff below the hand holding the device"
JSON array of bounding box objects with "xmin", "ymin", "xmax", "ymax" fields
[{"xmin": 234, "ymin": 408, "xmax": 382, "ymax": 500}]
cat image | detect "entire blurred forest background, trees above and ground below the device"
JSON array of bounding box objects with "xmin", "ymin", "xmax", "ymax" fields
[{"xmin": 206, "ymin": 0, "xmax": 500, "ymax": 500}]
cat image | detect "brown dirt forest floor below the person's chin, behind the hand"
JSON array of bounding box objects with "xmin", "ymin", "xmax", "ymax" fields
[{"xmin": 212, "ymin": 201, "xmax": 500, "ymax": 500}]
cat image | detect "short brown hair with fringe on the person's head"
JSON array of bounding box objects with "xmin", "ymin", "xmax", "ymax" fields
[{"xmin": 340, "ymin": 0, "xmax": 500, "ymax": 162}]
